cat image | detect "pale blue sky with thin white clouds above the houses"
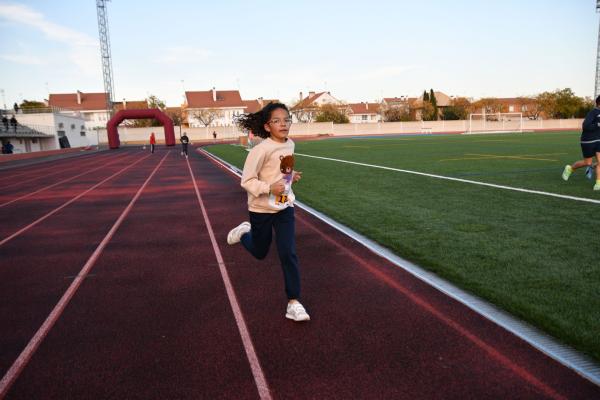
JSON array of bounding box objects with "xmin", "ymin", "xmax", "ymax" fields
[{"xmin": 0, "ymin": 0, "xmax": 599, "ymax": 107}]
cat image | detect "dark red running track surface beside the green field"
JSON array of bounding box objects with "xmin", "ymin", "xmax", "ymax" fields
[{"xmin": 0, "ymin": 149, "xmax": 600, "ymax": 399}]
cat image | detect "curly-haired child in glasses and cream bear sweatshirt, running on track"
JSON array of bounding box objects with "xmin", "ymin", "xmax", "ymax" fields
[{"xmin": 227, "ymin": 103, "xmax": 310, "ymax": 321}]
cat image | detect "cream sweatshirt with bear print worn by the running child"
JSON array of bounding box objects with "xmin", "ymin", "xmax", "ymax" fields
[{"xmin": 241, "ymin": 138, "xmax": 295, "ymax": 213}]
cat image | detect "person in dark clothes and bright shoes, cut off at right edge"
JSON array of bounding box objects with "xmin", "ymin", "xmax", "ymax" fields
[{"xmin": 562, "ymin": 96, "xmax": 600, "ymax": 191}]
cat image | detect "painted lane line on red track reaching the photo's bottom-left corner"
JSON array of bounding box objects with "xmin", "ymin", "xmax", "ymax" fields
[{"xmin": 0, "ymin": 151, "xmax": 170, "ymax": 399}]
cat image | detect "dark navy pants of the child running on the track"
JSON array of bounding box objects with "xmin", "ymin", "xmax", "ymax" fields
[{"xmin": 241, "ymin": 207, "xmax": 300, "ymax": 299}]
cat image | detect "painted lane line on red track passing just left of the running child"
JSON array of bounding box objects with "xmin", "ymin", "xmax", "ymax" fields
[{"xmin": 186, "ymin": 160, "xmax": 271, "ymax": 400}]
